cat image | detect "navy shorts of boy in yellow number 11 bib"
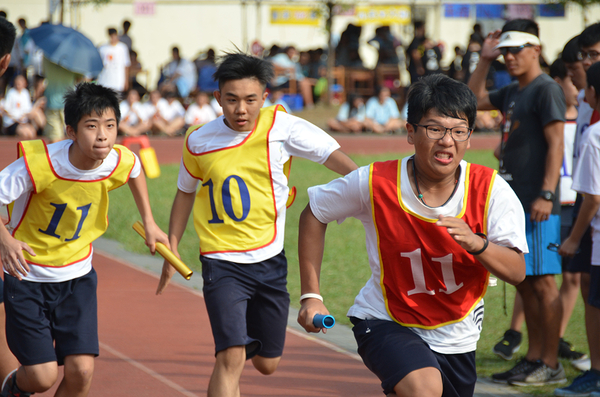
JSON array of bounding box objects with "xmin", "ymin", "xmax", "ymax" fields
[{"xmin": 4, "ymin": 269, "xmax": 100, "ymax": 365}]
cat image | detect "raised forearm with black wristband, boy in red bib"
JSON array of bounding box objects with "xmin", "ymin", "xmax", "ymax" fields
[{"xmin": 437, "ymin": 215, "xmax": 525, "ymax": 285}]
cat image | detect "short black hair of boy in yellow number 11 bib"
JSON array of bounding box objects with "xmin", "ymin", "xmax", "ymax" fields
[{"xmin": 64, "ymin": 82, "xmax": 121, "ymax": 132}]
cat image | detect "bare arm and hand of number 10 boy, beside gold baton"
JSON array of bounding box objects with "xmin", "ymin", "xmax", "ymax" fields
[{"xmin": 156, "ymin": 189, "xmax": 196, "ymax": 295}]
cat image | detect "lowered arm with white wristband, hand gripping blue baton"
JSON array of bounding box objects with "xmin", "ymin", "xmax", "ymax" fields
[{"xmin": 298, "ymin": 204, "xmax": 329, "ymax": 333}]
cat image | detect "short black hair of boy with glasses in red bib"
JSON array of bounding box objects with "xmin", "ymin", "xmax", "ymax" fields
[{"xmin": 406, "ymin": 73, "xmax": 477, "ymax": 128}]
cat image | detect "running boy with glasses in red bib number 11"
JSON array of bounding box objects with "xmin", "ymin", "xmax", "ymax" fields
[{"xmin": 298, "ymin": 74, "xmax": 527, "ymax": 397}]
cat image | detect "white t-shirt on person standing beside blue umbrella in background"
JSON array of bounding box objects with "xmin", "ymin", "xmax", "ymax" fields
[{"xmin": 98, "ymin": 42, "xmax": 131, "ymax": 92}]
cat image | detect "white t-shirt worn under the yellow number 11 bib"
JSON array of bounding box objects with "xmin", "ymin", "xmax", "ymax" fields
[{"xmin": 0, "ymin": 139, "xmax": 141, "ymax": 283}]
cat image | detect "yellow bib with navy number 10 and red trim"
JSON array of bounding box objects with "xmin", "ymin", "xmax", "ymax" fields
[{"xmin": 183, "ymin": 106, "xmax": 288, "ymax": 254}]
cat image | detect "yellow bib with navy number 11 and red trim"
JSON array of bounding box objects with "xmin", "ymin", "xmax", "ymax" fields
[{"xmin": 13, "ymin": 140, "xmax": 135, "ymax": 267}]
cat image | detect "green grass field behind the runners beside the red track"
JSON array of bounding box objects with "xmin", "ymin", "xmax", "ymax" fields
[{"xmin": 105, "ymin": 150, "xmax": 587, "ymax": 395}]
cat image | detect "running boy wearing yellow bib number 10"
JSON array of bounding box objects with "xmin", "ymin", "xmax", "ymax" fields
[{"xmin": 157, "ymin": 53, "xmax": 356, "ymax": 397}]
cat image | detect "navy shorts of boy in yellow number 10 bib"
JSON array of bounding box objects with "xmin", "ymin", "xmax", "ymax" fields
[{"xmin": 200, "ymin": 251, "xmax": 290, "ymax": 359}]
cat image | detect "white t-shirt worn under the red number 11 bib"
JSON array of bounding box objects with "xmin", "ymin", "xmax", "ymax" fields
[{"xmin": 308, "ymin": 158, "xmax": 528, "ymax": 354}]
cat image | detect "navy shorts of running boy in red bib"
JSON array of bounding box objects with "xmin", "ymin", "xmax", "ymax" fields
[{"xmin": 350, "ymin": 317, "xmax": 477, "ymax": 397}]
